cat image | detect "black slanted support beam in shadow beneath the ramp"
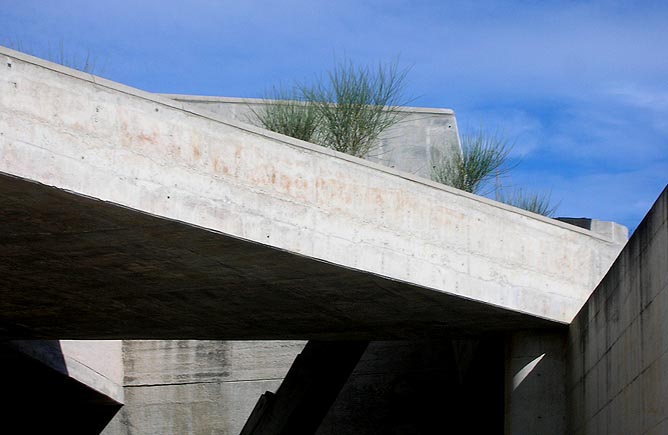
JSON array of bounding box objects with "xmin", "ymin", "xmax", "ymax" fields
[{"xmin": 241, "ymin": 341, "xmax": 368, "ymax": 435}]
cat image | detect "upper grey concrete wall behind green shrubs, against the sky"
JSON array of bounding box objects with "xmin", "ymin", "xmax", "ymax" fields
[{"xmin": 164, "ymin": 94, "xmax": 461, "ymax": 178}]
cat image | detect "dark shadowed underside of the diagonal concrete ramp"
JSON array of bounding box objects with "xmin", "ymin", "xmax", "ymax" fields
[{"xmin": 0, "ymin": 171, "xmax": 552, "ymax": 339}]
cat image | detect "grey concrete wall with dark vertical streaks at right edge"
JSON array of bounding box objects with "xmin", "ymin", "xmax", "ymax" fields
[{"xmin": 567, "ymin": 188, "xmax": 668, "ymax": 435}]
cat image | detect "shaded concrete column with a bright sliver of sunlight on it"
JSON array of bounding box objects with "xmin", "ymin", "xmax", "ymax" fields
[{"xmin": 505, "ymin": 330, "xmax": 567, "ymax": 435}]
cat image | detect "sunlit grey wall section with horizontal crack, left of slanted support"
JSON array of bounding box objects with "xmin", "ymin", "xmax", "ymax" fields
[{"xmin": 104, "ymin": 340, "xmax": 305, "ymax": 435}]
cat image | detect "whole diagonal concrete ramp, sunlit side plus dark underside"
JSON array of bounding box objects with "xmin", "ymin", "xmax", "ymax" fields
[{"xmin": 0, "ymin": 48, "xmax": 621, "ymax": 339}]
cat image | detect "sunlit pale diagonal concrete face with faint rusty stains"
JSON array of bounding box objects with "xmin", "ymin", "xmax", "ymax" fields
[{"xmin": 0, "ymin": 49, "xmax": 620, "ymax": 328}]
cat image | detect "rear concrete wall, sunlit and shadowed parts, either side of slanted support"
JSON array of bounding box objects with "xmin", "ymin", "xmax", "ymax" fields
[{"xmin": 104, "ymin": 335, "xmax": 506, "ymax": 435}]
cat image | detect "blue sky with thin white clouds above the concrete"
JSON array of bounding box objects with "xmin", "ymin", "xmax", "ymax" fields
[{"xmin": 0, "ymin": 0, "xmax": 668, "ymax": 233}]
